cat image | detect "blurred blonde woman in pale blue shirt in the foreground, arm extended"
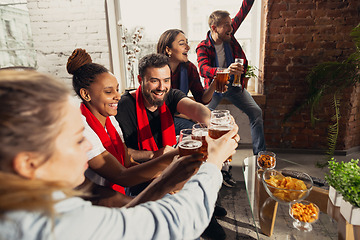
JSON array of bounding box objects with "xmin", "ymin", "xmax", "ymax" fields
[{"xmin": 0, "ymin": 70, "xmax": 240, "ymax": 240}]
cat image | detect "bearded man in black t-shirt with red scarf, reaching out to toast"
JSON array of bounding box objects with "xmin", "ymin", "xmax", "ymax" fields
[{"xmin": 116, "ymin": 54, "xmax": 210, "ymax": 162}]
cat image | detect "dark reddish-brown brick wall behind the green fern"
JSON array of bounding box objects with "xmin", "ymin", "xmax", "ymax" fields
[{"xmin": 263, "ymin": 0, "xmax": 360, "ymax": 150}]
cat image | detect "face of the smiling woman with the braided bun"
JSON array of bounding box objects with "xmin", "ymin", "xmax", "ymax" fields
[{"xmin": 83, "ymin": 72, "xmax": 120, "ymax": 124}]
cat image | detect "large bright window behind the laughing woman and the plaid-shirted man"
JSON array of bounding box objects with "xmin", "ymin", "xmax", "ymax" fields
[{"xmin": 107, "ymin": 0, "xmax": 261, "ymax": 90}]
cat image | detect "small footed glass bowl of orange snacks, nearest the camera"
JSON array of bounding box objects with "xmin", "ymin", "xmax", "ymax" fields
[{"xmin": 289, "ymin": 200, "xmax": 319, "ymax": 232}]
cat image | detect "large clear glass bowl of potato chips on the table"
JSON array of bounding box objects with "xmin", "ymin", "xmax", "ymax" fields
[{"xmin": 262, "ymin": 169, "xmax": 314, "ymax": 203}]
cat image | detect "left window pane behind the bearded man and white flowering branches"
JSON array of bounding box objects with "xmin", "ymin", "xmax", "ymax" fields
[{"xmin": 120, "ymin": 0, "xmax": 180, "ymax": 88}]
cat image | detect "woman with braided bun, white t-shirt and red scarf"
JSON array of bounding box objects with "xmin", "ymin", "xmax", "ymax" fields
[{"xmin": 67, "ymin": 48, "xmax": 178, "ymax": 207}]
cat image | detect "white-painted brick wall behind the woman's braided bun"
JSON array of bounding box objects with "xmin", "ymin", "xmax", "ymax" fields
[{"xmin": 27, "ymin": 0, "xmax": 110, "ymax": 86}]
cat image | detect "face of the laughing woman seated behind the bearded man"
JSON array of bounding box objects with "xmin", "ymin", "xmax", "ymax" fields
[{"xmin": 167, "ymin": 33, "xmax": 190, "ymax": 63}]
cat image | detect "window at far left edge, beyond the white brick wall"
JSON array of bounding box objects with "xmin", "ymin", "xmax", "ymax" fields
[{"xmin": 0, "ymin": 0, "xmax": 36, "ymax": 67}]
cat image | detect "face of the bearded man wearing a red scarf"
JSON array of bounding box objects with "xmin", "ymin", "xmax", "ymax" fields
[{"xmin": 141, "ymin": 65, "xmax": 171, "ymax": 111}]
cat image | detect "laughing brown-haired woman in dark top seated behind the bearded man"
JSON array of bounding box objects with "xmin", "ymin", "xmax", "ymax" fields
[{"xmin": 156, "ymin": 29, "xmax": 228, "ymax": 239}]
